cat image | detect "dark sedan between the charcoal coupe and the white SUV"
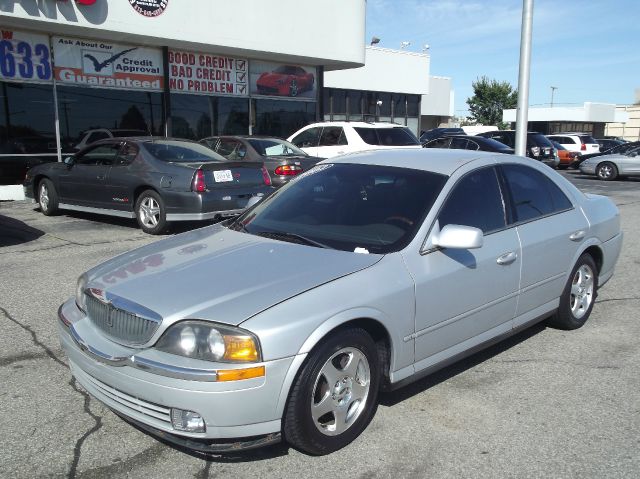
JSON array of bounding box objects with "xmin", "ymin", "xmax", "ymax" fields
[{"xmin": 200, "ymin": 136, "xmax": 324, "ymax": 187}]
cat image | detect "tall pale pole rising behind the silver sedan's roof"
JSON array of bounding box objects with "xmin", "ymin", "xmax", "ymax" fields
[{"xmin": 516, "ymin": 0, "xmax": 533, "ymax": 156}]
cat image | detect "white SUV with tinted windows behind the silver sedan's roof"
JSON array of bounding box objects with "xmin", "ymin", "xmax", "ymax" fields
[{"xmin": 287, "ymin": 121, "xmax": 422, "ymax": 158}]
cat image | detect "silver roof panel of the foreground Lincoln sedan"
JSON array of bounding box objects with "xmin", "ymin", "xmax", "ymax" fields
[{"xmin": 320, "ymin": 148, "xmax": 521, "ymax": 176}]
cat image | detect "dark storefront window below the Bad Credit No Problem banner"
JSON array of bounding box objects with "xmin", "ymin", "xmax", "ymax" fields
[{"xmin": 171, "ymin": 94, "xmax": 249, "ymax": 140}]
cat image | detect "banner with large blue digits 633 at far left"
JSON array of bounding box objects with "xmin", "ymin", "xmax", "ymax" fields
[{"xmin": 0, "ymin": 30, "xmax": 53, "ymax": 83}]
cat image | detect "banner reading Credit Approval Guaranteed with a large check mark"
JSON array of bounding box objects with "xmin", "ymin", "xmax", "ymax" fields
[{"xmin": 53, "ymin": 37, "xmax": 164, "ymax": 91}]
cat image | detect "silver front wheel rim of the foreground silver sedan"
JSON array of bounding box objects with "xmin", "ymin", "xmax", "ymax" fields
[{"xmin": 311, "ymin": 348, "xmax": 371, "ymax": 436}]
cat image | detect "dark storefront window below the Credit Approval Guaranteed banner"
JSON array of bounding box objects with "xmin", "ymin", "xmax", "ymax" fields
[{"xmin": 58, "ymin": 86, "xmax": 164, "ymax": 152}]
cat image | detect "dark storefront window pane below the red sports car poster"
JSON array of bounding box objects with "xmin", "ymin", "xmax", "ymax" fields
[{"xmin": 253, "ymin": 100, "xmax": 316, "ymax": 138}]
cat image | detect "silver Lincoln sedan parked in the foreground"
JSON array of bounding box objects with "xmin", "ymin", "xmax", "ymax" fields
[{"xmin": 59, "ymin": 149, "xmax": 622, "ymax": 454}]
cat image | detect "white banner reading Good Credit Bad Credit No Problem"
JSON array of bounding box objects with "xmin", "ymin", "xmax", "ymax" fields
[{"xmin": 169, "ymin": 50, "xmax": 249, "ymax": 96}]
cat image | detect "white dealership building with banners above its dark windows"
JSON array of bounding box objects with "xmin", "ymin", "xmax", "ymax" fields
[{"xmin": 0, "ymin": 0, "xmax": 450, "ymax": 200}]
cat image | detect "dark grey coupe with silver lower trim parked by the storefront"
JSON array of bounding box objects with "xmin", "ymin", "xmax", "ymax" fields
[{"xmin": 24, "ymin": 137, "xmax": 273, "ymax": 234}]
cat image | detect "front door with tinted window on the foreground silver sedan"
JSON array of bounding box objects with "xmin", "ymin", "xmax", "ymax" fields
[{"xmin": 407, "ymin": 166, "xmax": 521, "ymax": 370}]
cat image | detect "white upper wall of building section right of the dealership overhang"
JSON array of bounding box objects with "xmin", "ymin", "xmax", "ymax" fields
[{"xmin": 324, "ymin": 47, "xmax": 430, "ymax": 95}]
